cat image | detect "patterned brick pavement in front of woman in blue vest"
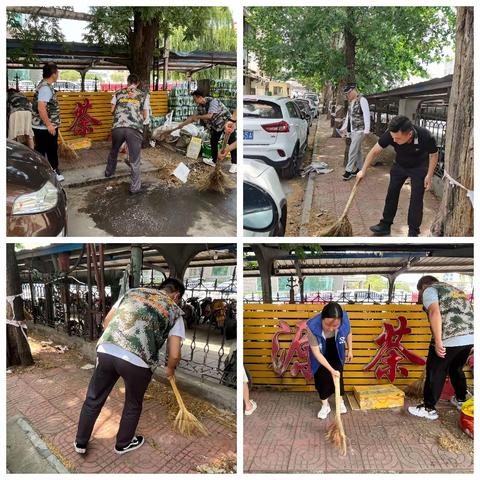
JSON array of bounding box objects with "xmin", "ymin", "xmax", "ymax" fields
[{"xmin": 244, "ymin": 390, "xmax": 473, "ymax": 474}]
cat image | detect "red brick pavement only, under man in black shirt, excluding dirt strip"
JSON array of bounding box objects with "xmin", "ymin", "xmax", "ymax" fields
[{"xmin": 310, "ymin": 115, "xmax": 440, "ymax": 237}]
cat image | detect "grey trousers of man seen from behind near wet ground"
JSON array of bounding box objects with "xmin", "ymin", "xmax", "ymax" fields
[{"xmin": 105, "ymin": 127, "xmax": 143, "ymax": 192}]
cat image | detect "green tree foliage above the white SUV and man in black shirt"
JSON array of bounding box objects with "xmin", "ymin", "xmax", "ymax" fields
[{"xmin": 245, "ymin": 7, "xmax": 455, "ymax": 93}]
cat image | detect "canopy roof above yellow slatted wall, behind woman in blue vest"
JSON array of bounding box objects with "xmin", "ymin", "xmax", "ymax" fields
[{"xmin": 244, "ymin": 244, "xmax": 473, "ymax": 277}]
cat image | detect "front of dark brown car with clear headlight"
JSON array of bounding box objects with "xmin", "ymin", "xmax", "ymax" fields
[{"xmin": 7, "ymin": 140, "xmax": 67, "ymax": 237}]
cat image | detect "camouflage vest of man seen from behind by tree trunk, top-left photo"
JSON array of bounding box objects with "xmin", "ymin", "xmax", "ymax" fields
[{"xmin": 112, "ymin": 86, "xmax": 147, "ymax": 132}]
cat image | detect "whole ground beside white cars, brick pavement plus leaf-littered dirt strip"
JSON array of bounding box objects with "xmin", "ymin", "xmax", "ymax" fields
[{"xmin": 284, "ymin": 115, "xmax": 440, "ymax": 237}]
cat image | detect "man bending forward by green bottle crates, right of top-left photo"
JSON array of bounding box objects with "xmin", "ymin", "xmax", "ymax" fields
[{"xmin": 172, "ymin": 89, "xmax": 232, "ymax": 167}]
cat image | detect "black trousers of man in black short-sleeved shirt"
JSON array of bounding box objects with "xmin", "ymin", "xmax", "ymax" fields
[{"xmin": 382, "ymin": 163, "xmax": 428, "ymax": 235}]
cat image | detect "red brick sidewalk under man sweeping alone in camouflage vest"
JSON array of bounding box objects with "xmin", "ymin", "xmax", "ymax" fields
[{"xmin": 7, "ymin": 339, "xmax": 236, "ymax": 473}]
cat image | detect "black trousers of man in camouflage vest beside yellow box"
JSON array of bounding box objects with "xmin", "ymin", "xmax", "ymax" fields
[{"xmin": 423, "ymin": 345, "xmax": 473, "ymax": 408}]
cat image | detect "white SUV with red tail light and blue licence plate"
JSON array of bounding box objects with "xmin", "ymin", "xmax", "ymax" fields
[{"xmin": 243, "ymin": 96, "xmax": 308, "ymax": 178}]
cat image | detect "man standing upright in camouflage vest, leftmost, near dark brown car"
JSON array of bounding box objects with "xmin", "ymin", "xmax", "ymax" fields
[{"xmin": 32, "ymin": 62, "xmax": 64, "ymax": 182}]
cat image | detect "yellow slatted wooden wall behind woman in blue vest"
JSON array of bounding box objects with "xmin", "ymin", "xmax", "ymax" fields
[{"xmin": 243, "ymin": 304, "xmax": 473, "ymax": 391}]
